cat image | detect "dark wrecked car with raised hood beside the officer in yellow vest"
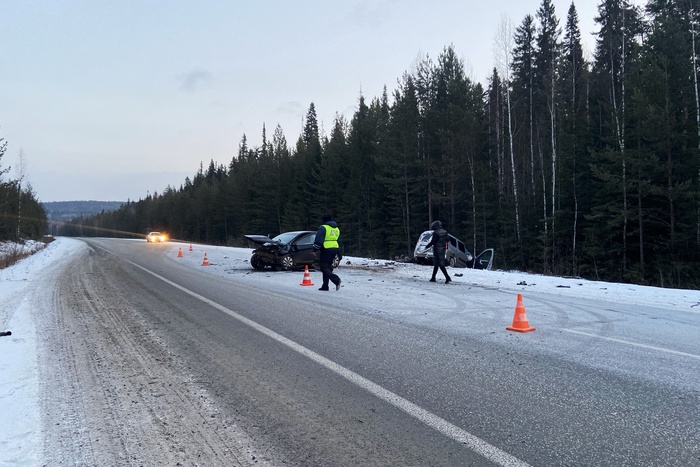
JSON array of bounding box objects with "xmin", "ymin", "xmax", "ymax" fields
[{"xmin": 244, "ymin": 230, "xmax": 342, "ymax": 271}]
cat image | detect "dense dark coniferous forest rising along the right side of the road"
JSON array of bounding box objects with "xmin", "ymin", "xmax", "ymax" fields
[{"xmin": 61, "ymin": 0, "xmax": 700, "ymax": 288}]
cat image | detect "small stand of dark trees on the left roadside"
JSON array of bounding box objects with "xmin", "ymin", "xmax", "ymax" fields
[{"xmin": 0, "ymin": 132, "xmax": 47, "ymax": 242}]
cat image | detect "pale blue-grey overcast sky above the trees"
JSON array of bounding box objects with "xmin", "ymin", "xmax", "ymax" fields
[{"xmin": 0, "ymin": 0, "xmax": 644, "ymax": 201}]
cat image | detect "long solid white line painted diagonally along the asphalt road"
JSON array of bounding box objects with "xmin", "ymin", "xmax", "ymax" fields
[{"xmin": 125, "ymin": 260, "xmax": 529, "ymax": 467}]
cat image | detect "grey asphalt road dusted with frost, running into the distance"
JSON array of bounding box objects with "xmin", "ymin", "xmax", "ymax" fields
[{"xmin": 42, "ymin": 239, "xmax": 700, "ymax": 466}]
